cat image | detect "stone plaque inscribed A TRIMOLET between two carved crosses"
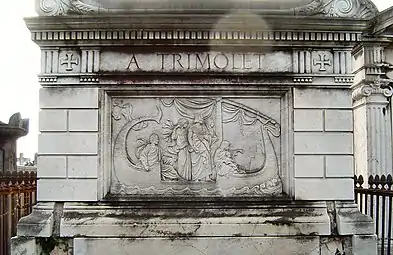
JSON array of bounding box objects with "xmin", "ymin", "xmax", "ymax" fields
[{"xmin": 100, "ymin": 51, "xmax": 293, "ymax": 73}]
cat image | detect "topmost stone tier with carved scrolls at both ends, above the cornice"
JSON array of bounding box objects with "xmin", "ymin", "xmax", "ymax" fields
[{"xmin": 36, "ymin": 0, "xmax": 378, "ymax": 19}]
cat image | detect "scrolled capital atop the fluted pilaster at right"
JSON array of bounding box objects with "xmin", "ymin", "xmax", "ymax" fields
[{"xmin": 352, "ymin": 78, "xmax": 393, "ymax": 101}]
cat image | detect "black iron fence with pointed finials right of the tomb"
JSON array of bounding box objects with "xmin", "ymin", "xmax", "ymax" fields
[{"xmin": 354, "ymin": 174, "xmax": 393, "ymax": 255}]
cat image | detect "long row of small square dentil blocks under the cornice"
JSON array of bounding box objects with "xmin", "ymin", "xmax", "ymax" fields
[{"xmin": 32, "ymin": 29, "xmax": 361, "ymax": 42}]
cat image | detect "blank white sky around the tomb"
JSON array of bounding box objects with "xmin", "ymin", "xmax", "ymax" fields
[{"xmin": 0, "ymin": 0, "xmax": 393, "ymax": 158}]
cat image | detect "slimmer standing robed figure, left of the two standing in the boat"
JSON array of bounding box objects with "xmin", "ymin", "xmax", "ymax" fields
[{"xmin": 171, "ymin": 118, "xmax": 192, "ymax": 181}]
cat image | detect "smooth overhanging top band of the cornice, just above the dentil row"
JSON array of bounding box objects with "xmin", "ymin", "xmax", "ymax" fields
[{"xmin": 25, "ymin": 12, "xmax": 369, "ymax": 32}]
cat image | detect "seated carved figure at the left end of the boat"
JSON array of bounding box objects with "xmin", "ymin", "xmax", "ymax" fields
[{"xmin": 137, "ymin": 133, "xmax": 161, "ymax": 172}]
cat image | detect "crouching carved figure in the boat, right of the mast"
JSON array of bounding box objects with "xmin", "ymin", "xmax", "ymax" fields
[{"xmin": 214, "ymin": 140, "xmax": 240, "ymax": 177}]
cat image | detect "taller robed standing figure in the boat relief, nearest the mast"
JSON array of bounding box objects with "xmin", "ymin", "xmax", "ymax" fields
[{"xmin": 188, "ymin": 115, "xmax": 215, "ymax": 181}]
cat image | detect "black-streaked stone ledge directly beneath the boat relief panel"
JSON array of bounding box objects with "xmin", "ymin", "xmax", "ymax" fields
[{"xmin": 56, "ymin": 205, "xmax": 331, "ymax": 238}]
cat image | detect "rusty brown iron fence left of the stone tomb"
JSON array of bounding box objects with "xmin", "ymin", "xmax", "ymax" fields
[{"xmin": 0, "ymin": 171, "xmax": 37, "ymax": 255}]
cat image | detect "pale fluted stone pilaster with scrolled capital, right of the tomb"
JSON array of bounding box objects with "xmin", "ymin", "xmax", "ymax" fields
[{"xmin": 352, "ymin": 78, "xmax": 393, "ymax": 176}]
